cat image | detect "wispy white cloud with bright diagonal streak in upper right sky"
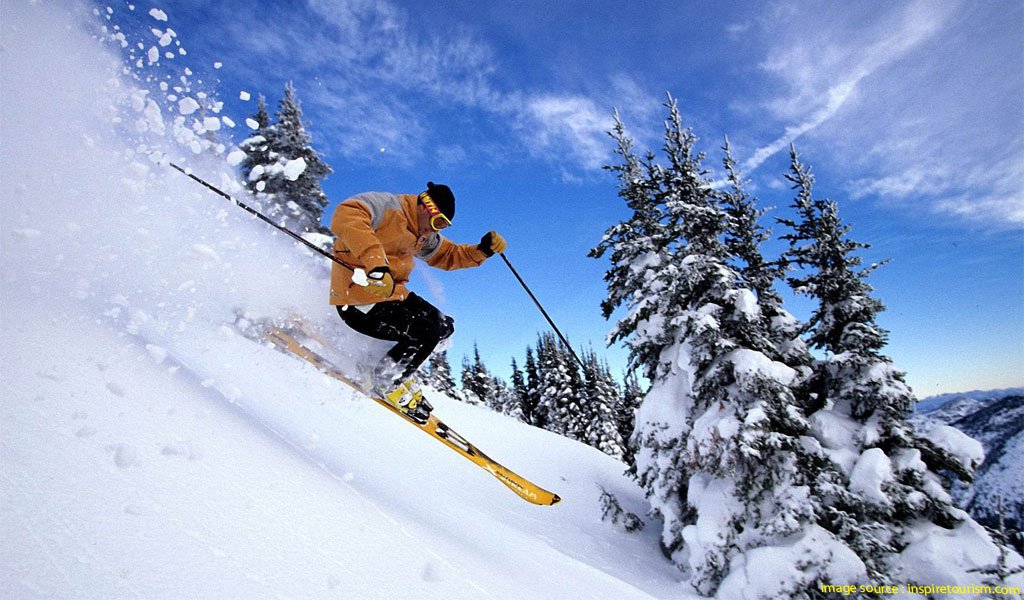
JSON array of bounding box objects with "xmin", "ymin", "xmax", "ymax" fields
[{"xmin": 742, "ymin": 1, "xmax": 1024, "ymax": 228}]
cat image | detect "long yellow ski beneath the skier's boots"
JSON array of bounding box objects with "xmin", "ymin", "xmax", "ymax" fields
[{"xmin": 263, "ymin": 326, "xmax": 561, "ymax": 506}]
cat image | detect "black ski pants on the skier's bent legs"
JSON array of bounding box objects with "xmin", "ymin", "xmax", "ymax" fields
[{"xmin": 338, "ymin": 293, "xmax": 455, "ymax": 385}]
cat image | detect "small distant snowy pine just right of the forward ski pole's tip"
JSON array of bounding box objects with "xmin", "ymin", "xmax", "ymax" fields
[{"xmin": 581, "ymin": 350, "xmax": 626, "ymax": 460}]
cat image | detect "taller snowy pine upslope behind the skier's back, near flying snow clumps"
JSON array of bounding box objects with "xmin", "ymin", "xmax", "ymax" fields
[{"xmin": 265, "ymin": 83, "xmax": 332, "ymax": 235}]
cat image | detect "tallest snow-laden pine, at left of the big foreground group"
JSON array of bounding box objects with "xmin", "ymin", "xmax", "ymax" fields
[{"xmin": 598, "ymin": 96, "xmax": 864, "ymax": 598}]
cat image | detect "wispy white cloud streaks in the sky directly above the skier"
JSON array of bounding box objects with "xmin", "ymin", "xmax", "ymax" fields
[{"xmin": 203, "ymin": 0, "xmax": 626, "ymax": 170}]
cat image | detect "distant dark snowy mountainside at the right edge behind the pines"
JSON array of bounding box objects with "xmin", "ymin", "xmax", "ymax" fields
[{"xmin": 912, "ymin": 388, "xmax": 1024, "ymax": 547}]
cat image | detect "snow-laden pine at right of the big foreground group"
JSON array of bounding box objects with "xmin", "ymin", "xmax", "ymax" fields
[{"xmin": 781, "ymin": 147, "xmax": 1020, "ymax": 585}]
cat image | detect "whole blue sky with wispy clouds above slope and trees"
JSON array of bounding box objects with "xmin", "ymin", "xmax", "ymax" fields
[{"xmin": 99, "ymin": 0, "xmax": 1024, "ymax": 396}]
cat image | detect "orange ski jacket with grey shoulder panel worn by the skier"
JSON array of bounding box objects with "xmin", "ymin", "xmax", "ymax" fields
[{"xmin": 331, "ymin": 191, "xmax": 487, "ymax": 305}]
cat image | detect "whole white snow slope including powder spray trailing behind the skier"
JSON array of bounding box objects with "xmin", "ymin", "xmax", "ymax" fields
[{"xmin": 0, "ymin": 2, "xmax": 686, "ymax": 599}]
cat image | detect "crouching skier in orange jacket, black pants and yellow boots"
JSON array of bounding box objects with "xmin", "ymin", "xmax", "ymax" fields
[{"xmin": 331, "ymin": 181, "xmax": 507, "ymax": 419}]
